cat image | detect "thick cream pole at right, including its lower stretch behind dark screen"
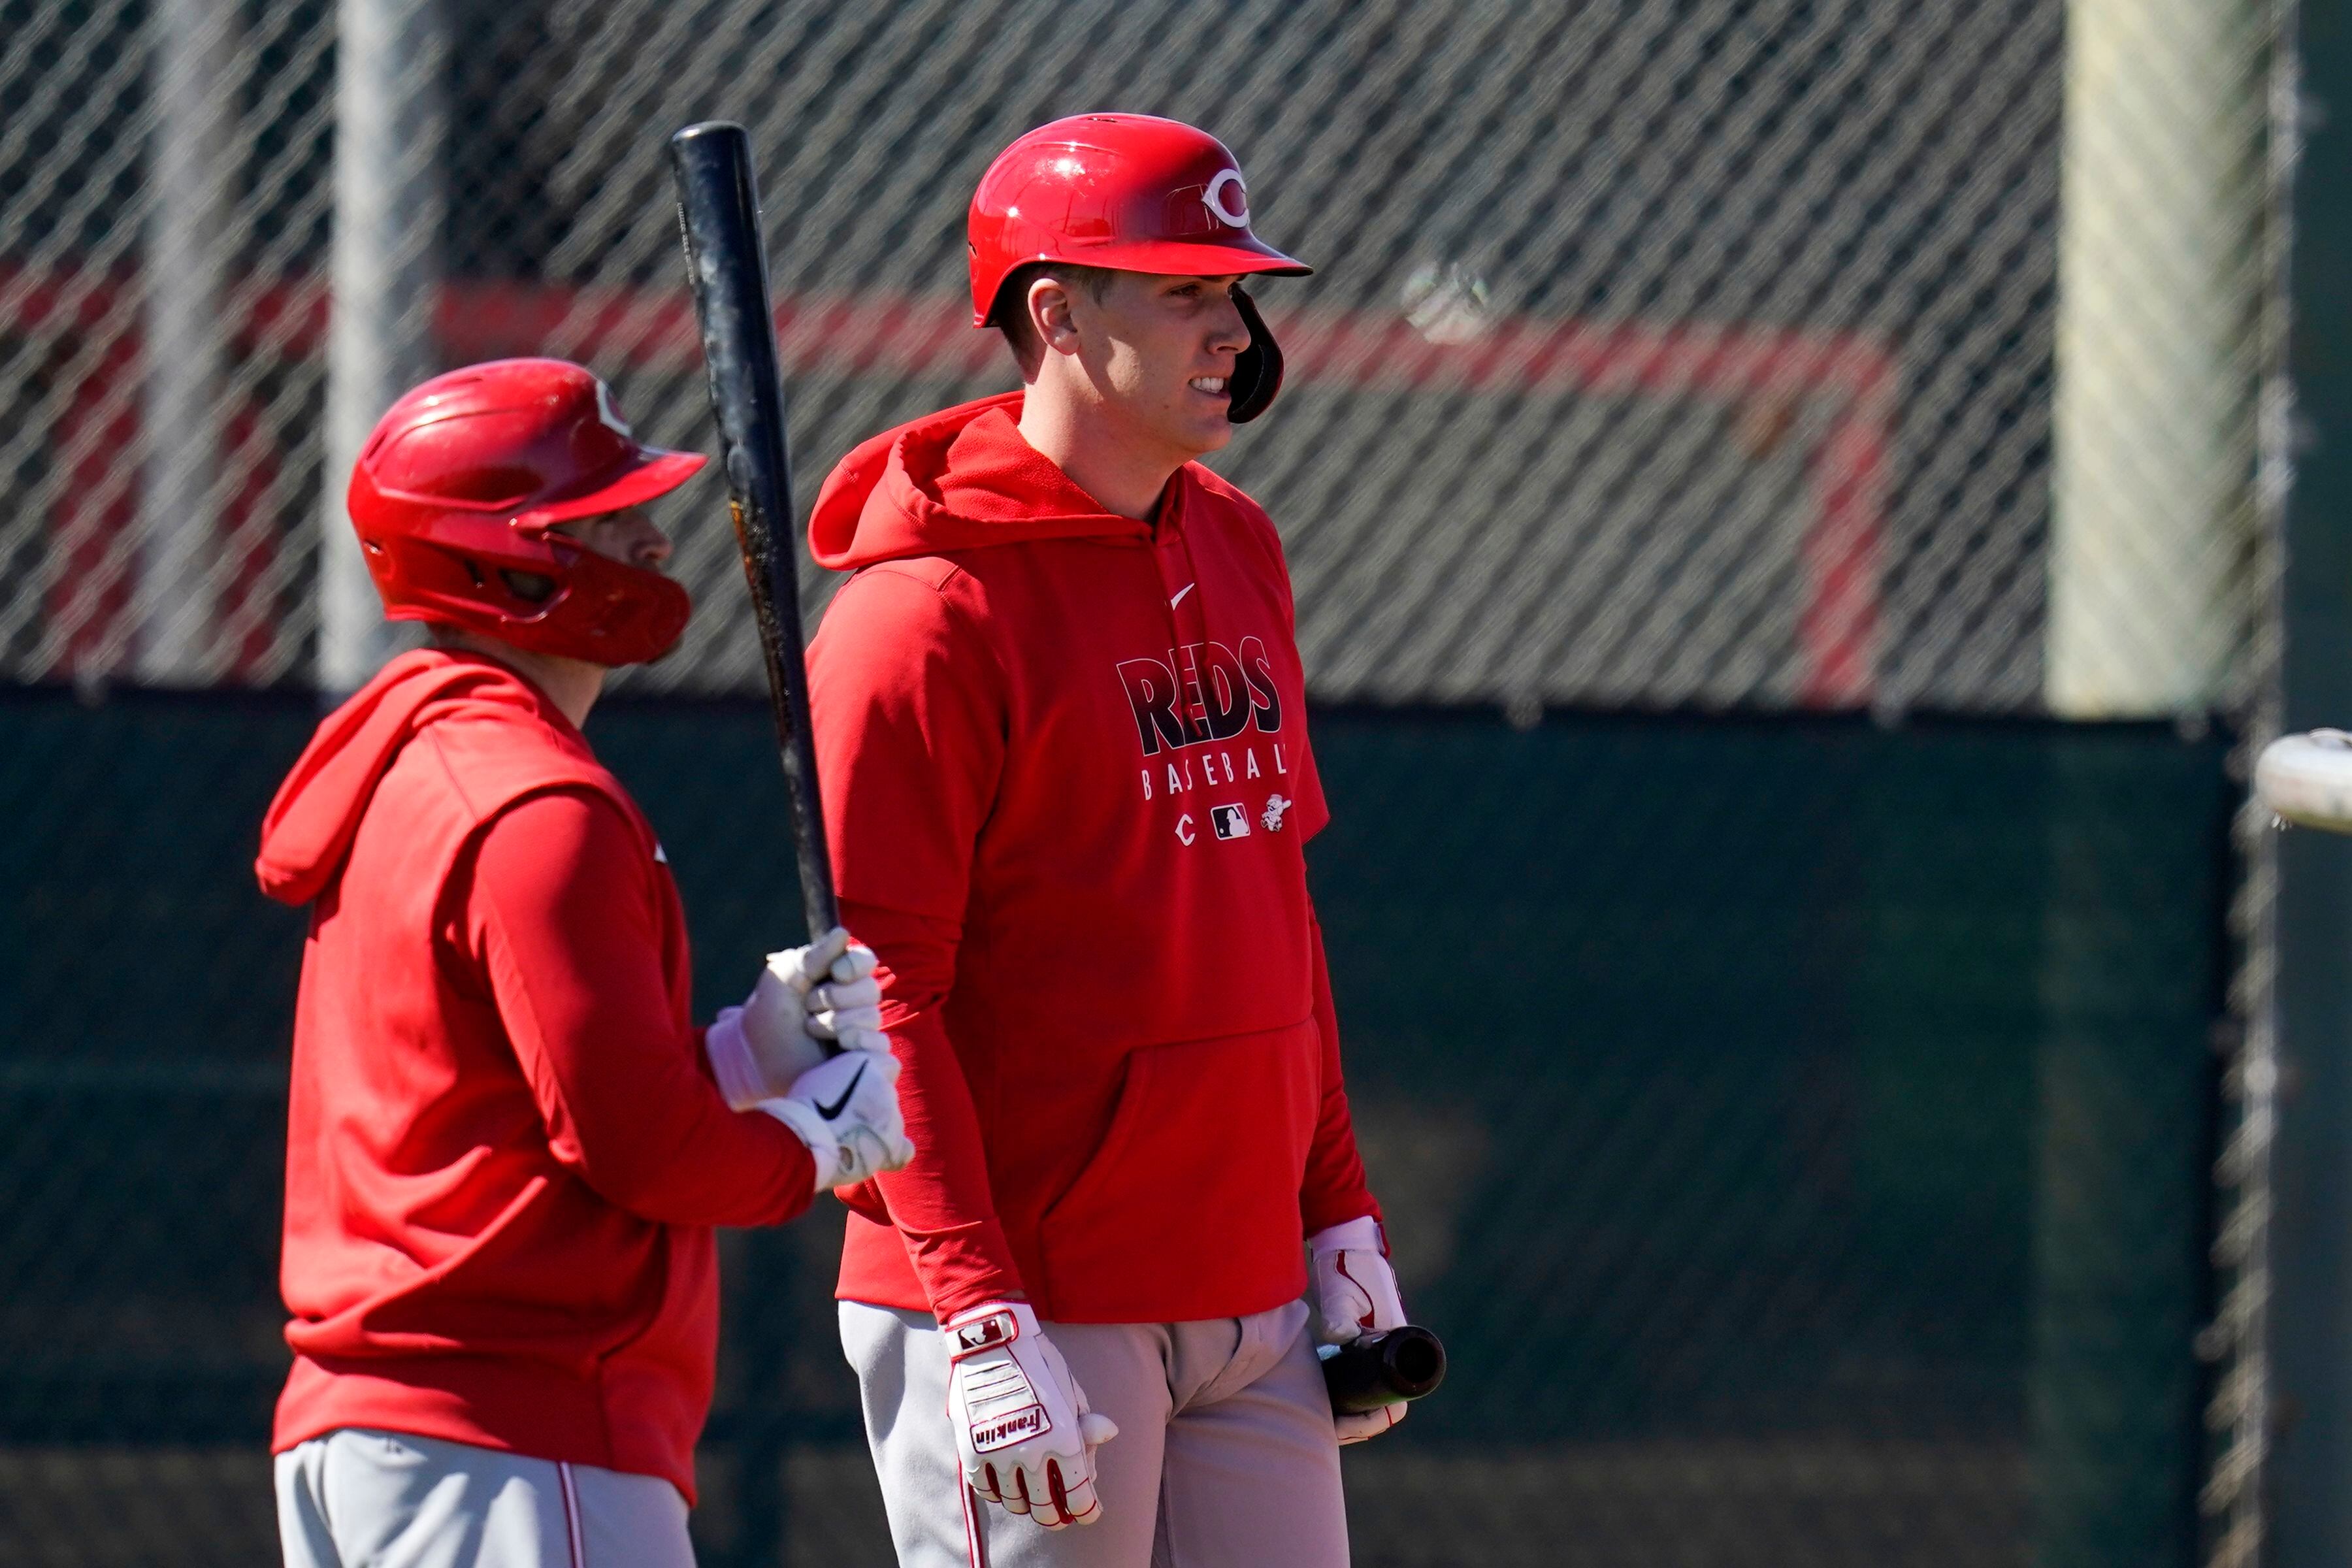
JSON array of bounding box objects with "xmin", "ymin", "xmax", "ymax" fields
[{"xmin": 2025, "ymin": 0, "xmax": 2270, "ymax": 1563}]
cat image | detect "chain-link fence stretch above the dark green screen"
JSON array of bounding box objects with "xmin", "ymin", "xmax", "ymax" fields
[{"xmin": 0, "ymin": 0, "xmax": 2272, "ymax": 712}]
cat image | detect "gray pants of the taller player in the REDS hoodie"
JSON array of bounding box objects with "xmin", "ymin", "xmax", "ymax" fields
[{"xmin": 840, "ymin": 1302, "xmax": 1348, "ymax": 1568}]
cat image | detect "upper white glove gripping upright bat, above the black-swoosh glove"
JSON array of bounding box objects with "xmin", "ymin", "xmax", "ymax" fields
[{"xmin": 703, "ymin": 926, "xmax": 889, "ymax": 1109}]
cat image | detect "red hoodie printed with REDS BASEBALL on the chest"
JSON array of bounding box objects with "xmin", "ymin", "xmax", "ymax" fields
[{"xmin": 809, "ymin": 393, "xmax": 1376, "ymax": 1324}]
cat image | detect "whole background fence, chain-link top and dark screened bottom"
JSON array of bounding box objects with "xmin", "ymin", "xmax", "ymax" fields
[{"xmin": 0, "ymin": 0, "xmax": 2293, "ymax": 1565}]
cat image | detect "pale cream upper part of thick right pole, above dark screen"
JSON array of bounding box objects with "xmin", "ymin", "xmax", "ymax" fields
[{"xmin": 2044, "ymin": 0, "xmax": 2265, "ymax": 719}]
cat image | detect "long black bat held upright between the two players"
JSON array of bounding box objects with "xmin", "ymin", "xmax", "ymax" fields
[{"xmin": 670, "ymin": 120, "xmax": 842, "ymax": 940}]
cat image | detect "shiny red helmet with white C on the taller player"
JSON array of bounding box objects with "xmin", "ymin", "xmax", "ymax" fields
[{"xmin": 967, "ymin": 115, "xmax": 1315, "ymax": 423}]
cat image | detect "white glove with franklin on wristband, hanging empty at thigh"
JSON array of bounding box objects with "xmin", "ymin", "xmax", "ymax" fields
[{"xmin": 945, "ymin": 1302, "xmax": 1120, "ymax": 1530}]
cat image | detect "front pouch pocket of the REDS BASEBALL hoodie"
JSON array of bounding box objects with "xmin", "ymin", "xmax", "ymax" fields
[{"xmin": 1039, "ymin": 1018, "xmax": 1322, "ymax": 1324}]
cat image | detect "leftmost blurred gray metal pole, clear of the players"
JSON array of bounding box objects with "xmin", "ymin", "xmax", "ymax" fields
[{"xmin": 132, "ymin": 0, "xmax": 235, "ymax": 687}]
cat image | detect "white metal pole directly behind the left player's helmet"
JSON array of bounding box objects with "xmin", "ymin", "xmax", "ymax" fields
[{"xmin": 318, "ymin": 0, "xmax": 447, "ymax": 693}]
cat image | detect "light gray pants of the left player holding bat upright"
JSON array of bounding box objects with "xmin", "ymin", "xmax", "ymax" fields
[{"xmin": 278, "ymin": 1427, "xmax": 694, "ymax": 1568}]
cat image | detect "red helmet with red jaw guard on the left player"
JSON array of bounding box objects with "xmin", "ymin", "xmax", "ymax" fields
[{"xmin": 348, "ymin": 360, "xmax": 703, "ymax": 665}]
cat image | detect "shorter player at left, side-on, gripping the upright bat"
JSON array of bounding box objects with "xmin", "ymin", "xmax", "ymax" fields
[{"xmin": 256, "ymin": 360, "xmax": 910, "ymax": 1568}]
